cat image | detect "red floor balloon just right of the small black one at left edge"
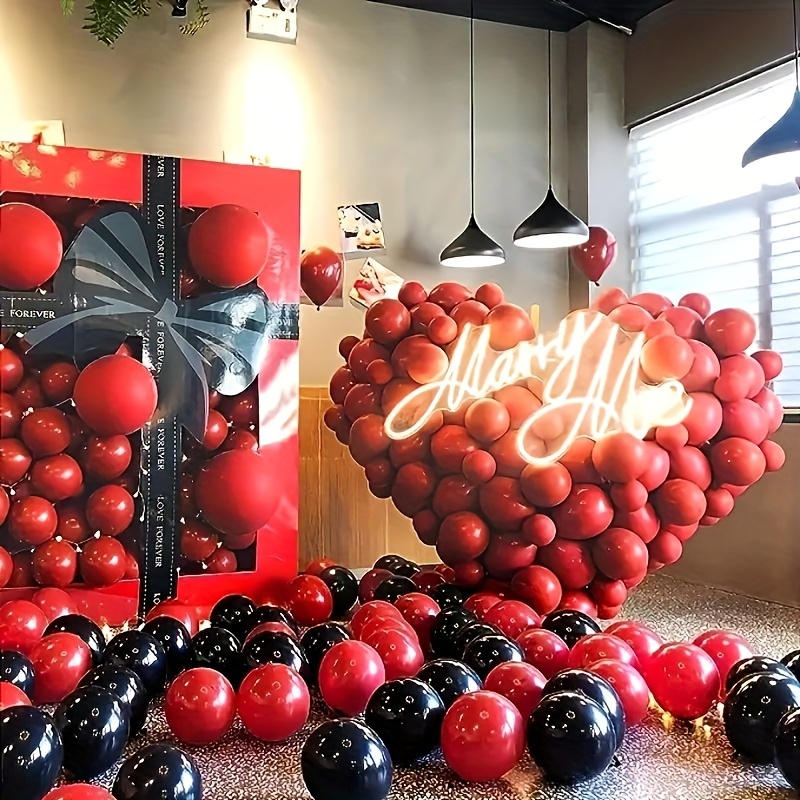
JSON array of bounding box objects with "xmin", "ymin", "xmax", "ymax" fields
[{"xmin": 30, "ymin": 633, "xmax": 92, "ymax": 705}]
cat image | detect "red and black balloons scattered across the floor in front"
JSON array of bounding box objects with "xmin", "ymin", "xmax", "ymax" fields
[{"xmin": 0, "ymin": 556, "xmax": 800, "ymax": 800}]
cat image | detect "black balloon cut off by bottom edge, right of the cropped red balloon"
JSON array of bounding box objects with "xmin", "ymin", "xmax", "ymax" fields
[{"xmin": 111, "ymin": 742, "xmax": 203, "ymax": 800}]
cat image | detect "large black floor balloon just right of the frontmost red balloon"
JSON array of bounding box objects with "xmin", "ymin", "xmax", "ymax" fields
[{"xmin": 528, "ymin": 692, "xmax": 616, "ymax": 784}]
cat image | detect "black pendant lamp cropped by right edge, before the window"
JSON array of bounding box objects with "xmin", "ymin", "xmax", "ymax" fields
[{"xmin": 742, "ymin": 0, "xmax": 800, "ymax": 183}]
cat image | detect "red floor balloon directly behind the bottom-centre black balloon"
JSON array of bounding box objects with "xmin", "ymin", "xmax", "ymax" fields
[{"xmin": 319, "ymin": 640, "xmax": 386, "ymax": 717}]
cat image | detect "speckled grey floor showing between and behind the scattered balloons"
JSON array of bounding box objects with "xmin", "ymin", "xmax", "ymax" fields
[{"xmin": 95, "ymin": 576, "xmax": 800, "ymax": 800}]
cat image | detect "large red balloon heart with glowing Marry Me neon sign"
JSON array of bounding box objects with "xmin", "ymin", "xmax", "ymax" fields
[{"xmin": 325, "ymin": 282, "xmax": 785, "ymax": 618}]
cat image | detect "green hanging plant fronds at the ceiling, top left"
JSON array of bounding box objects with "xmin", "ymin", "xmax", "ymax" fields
[{"xmin": 61, "ymin": 0, "xmax": 211, "ymax": 46}]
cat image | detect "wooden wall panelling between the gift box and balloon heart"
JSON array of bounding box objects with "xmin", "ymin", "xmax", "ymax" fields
[{"xmin": 300, "ymin": 386, "xmax": 438, "ymax": 568}]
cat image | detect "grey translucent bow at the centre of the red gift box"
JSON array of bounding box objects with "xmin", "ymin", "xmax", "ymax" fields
[{"xmin": 25, "ymin": 204, "xmax": 276, "ymax": 441}]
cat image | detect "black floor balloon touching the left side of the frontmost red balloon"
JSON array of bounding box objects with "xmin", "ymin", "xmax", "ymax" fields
[{"xmin": 364, "ymin": 678, "xmax": 445, "ymax": 765}]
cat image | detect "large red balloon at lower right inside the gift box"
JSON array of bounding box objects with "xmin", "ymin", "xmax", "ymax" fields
[{"xmin": 195, "ymin": 449, "xmax": 280, "ymax": 534}]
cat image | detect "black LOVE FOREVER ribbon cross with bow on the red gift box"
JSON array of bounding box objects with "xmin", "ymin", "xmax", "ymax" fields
[{"xmin": 0, "ymin": 156, "xmax": 298, "ymax": 614}]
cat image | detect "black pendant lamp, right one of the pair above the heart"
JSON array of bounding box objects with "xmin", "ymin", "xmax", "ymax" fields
[{"xmin": 514, "ymin": 31, "xmax": 589, "ymax": 250}]
